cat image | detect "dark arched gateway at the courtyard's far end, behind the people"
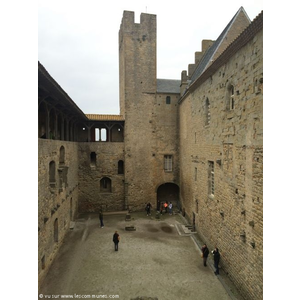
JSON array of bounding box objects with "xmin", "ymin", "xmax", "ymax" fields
[{"xmin": 156, "ymin": 182, "xmax": 180, "ymax": 209}]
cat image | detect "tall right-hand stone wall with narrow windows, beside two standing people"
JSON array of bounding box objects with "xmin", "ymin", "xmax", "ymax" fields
[{"xmin": 179, "ymin": 14, "xmax": 263, "ymax": 300}]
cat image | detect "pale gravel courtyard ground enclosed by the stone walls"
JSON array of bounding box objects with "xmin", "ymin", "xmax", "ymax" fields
[{"xmin": 39, "ymin": 213, "xmax": 243, "ymax": 300}]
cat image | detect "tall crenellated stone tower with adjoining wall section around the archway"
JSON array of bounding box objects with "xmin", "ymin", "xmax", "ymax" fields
[{"xmin": 119, "ymin": 11, "xmax": 180, "ymax": 210}]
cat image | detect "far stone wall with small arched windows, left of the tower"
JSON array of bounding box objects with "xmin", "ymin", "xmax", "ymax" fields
[{"xmin": 78, "ymin": 142, "xmax": 126, "ymax": 212}]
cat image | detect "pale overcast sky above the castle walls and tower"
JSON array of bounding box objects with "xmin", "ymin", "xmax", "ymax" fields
[{"xmin": 38, "ymin": 0, "xmax": 263, "ymax": 114}]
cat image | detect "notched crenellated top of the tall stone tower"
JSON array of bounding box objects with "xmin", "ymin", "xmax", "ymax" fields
[{"xmin": 120, "ymin": 10, "xmax": 156, "ymax": 31}]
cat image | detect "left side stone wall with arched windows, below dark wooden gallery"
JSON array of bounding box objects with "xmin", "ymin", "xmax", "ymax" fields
[{"xmin": 38, "ymin": 139, "xmax": 78, "ymax": 284}]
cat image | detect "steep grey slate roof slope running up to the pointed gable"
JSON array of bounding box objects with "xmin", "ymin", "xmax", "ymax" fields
[{"xmin": 191, "ymin": 7, "xmax": 251, "ymax": 84}]
